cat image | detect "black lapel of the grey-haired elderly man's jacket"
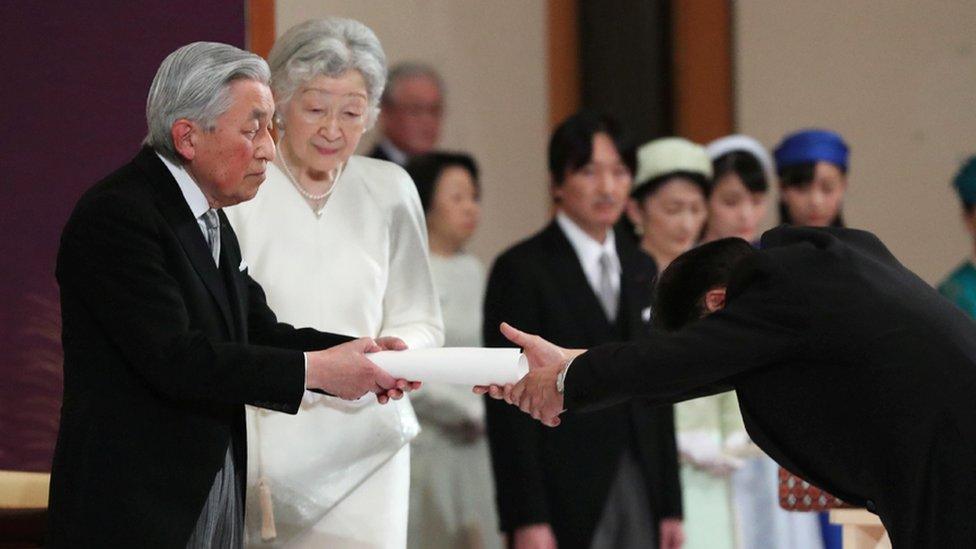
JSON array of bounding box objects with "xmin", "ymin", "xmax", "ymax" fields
[{"xmin": 136, "ymin": 147, "xmax": 236, "ymax": 335}]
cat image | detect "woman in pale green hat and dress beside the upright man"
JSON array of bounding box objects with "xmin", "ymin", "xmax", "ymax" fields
[{"xmin": 627, "ymin": 137, "xmax": 748, "ymax": 549}]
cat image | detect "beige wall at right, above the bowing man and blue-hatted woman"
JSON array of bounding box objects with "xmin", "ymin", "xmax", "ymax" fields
[{"xmin": 735, "ymin": 0, "xmax": 976, "ymax": 282}]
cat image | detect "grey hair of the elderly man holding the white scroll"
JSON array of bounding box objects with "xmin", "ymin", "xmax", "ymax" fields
[{"xmin": 143, "ymin": 42, "xmax": 271, "ymax": 164}]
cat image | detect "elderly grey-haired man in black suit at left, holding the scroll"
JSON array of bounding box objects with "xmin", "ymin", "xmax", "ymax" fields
[{"xmin": 49, "ymin": 42, "xmax": 415, "ymax": 547}]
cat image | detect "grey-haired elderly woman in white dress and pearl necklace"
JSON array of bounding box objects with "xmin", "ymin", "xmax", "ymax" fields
[{"xmin": 228, "ymin": 18, "xmax": 444, "ymax": 548}]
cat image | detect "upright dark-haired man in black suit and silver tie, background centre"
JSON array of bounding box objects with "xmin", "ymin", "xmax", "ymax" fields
[{"xmin": 484, "ymin": 112, "xmax": 683, "ymax": 549}]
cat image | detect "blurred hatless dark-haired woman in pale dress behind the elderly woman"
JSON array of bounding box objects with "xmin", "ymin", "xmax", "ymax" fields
[{"xmin": 407, "ymin": 153, "xmax": 502, "ymax": 549}]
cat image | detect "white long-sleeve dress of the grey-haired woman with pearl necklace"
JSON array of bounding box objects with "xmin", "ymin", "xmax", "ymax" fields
[{"xmin": 227, "ymin": 156, "xmax": 444, "ymax": 548}]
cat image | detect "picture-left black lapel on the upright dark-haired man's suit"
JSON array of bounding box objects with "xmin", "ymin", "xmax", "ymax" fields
[{"xmin": 545, "ymin": 221, "xmax": 612, "ymax": 334}]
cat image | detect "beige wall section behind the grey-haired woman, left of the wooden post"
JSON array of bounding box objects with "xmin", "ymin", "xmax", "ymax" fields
[{"xmin": 276, "ymin": 0, "xmax": 548, "ymax": 262}]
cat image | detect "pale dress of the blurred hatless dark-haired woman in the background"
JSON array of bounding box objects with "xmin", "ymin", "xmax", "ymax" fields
[{"xmin": 407, "ymin": 253, "xmax": 502, "ymax": 549}]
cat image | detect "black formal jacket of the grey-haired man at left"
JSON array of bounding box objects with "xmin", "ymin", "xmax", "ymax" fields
[{"xmin": 49, "ymin": 148, "xmax": 350, "ymax": 548}]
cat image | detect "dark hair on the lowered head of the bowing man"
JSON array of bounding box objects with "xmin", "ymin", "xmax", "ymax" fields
[{"xmin": 653, "ymin": 238, "xmax": 756, "ymax": 331}]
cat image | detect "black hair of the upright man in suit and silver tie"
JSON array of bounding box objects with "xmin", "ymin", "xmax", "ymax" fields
[{"xmin": 549, "ymin": 110, "xmax": 637, "ymax": 187}]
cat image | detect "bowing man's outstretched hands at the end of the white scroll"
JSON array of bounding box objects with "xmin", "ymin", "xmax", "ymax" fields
[{"xmin": 474, "ymin": 322, "xmax": 584, "ymax": 427}]
